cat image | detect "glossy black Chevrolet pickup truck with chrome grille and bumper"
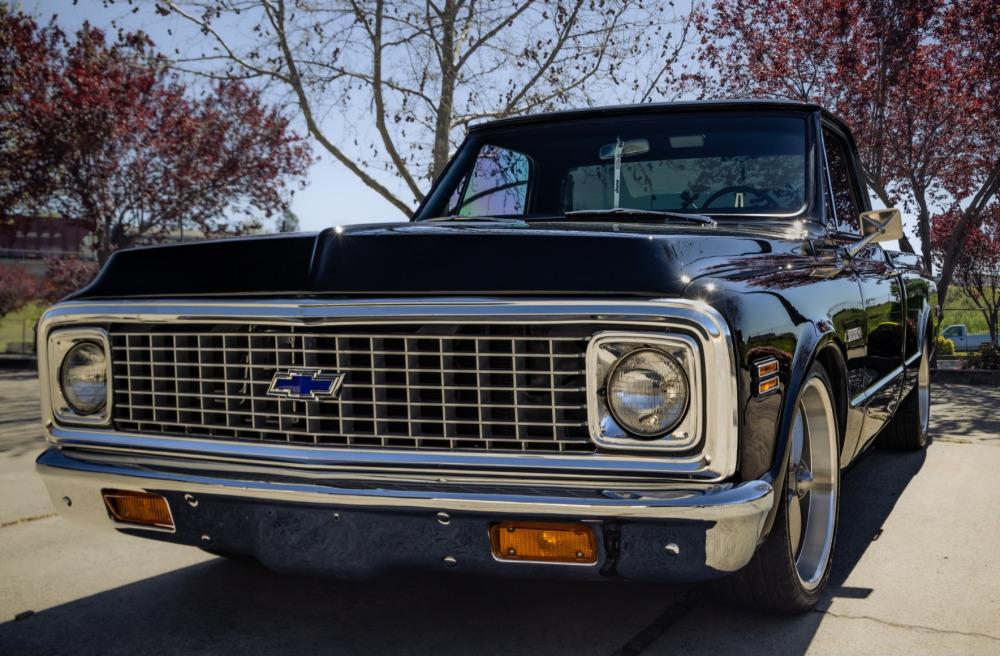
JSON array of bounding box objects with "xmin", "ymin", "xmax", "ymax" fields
[{"xmin": 38, "ymin": 102, "xmax": 936, "ymax": 611}]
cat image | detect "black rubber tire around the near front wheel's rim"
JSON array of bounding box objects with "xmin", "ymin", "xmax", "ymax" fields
[{"xmin": 719, "ymin": 363, "xmax": 841, "ymax": 613}]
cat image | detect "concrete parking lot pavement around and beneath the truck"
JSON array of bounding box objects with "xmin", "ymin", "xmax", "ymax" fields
[{"xmin": 0, "ymin": 373, "xmax": 1000, "ymax": 656}]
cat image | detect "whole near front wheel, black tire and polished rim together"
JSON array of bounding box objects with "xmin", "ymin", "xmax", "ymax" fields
[{"xmin": 729, "ymin": 363, "xmax": 840, "ymax": 613}]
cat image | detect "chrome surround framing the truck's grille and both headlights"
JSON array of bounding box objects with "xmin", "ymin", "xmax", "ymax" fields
[{"xmin": 38, "ymin": 298, "xmax": 738, "ymax": 481}]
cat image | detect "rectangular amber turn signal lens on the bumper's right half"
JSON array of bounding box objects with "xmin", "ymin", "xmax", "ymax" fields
[{"xmin": 490, "ymin": 522, "xmax": 597, "ymax": 565}]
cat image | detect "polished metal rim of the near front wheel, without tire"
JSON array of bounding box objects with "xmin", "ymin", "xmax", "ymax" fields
[{"xmin": 786, "ymin": 376, "xmax": 840, "ymax": 591}]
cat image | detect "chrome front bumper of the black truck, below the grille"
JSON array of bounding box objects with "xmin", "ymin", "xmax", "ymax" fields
[{"xmin": 37, "ymin": 447, "xmax": 774, "ymax": 581}]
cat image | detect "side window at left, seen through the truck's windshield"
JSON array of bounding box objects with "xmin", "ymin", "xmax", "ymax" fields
[{"xmin": 448, "ymin": 145, "xmax": 531, "ymax": 216}]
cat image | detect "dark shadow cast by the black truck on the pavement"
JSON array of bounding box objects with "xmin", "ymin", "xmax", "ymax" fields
[{"xmin": 0, "ymin": 446, "xmax": 933, "ymax": 656}]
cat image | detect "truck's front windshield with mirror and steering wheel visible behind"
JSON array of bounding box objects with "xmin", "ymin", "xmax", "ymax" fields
[{"xmin": 422, "ymin": 114, "xmax": 808, "ymax": 218}]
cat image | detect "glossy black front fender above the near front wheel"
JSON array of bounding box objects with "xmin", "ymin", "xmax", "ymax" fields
[{"xmin": 685, "ymin": 256, "xmax": 865, "ymax": 490}]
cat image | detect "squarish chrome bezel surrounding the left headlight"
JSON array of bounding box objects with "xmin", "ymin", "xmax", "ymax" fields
[{"xmin": 46, "ymin": 328, "xmax": 112, "ymax": 426}]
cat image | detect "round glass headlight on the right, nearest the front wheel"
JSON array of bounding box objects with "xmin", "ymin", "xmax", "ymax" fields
[{"xmin": 607, "ymin": 348, "xmax": 689, "ymax": 437}]
